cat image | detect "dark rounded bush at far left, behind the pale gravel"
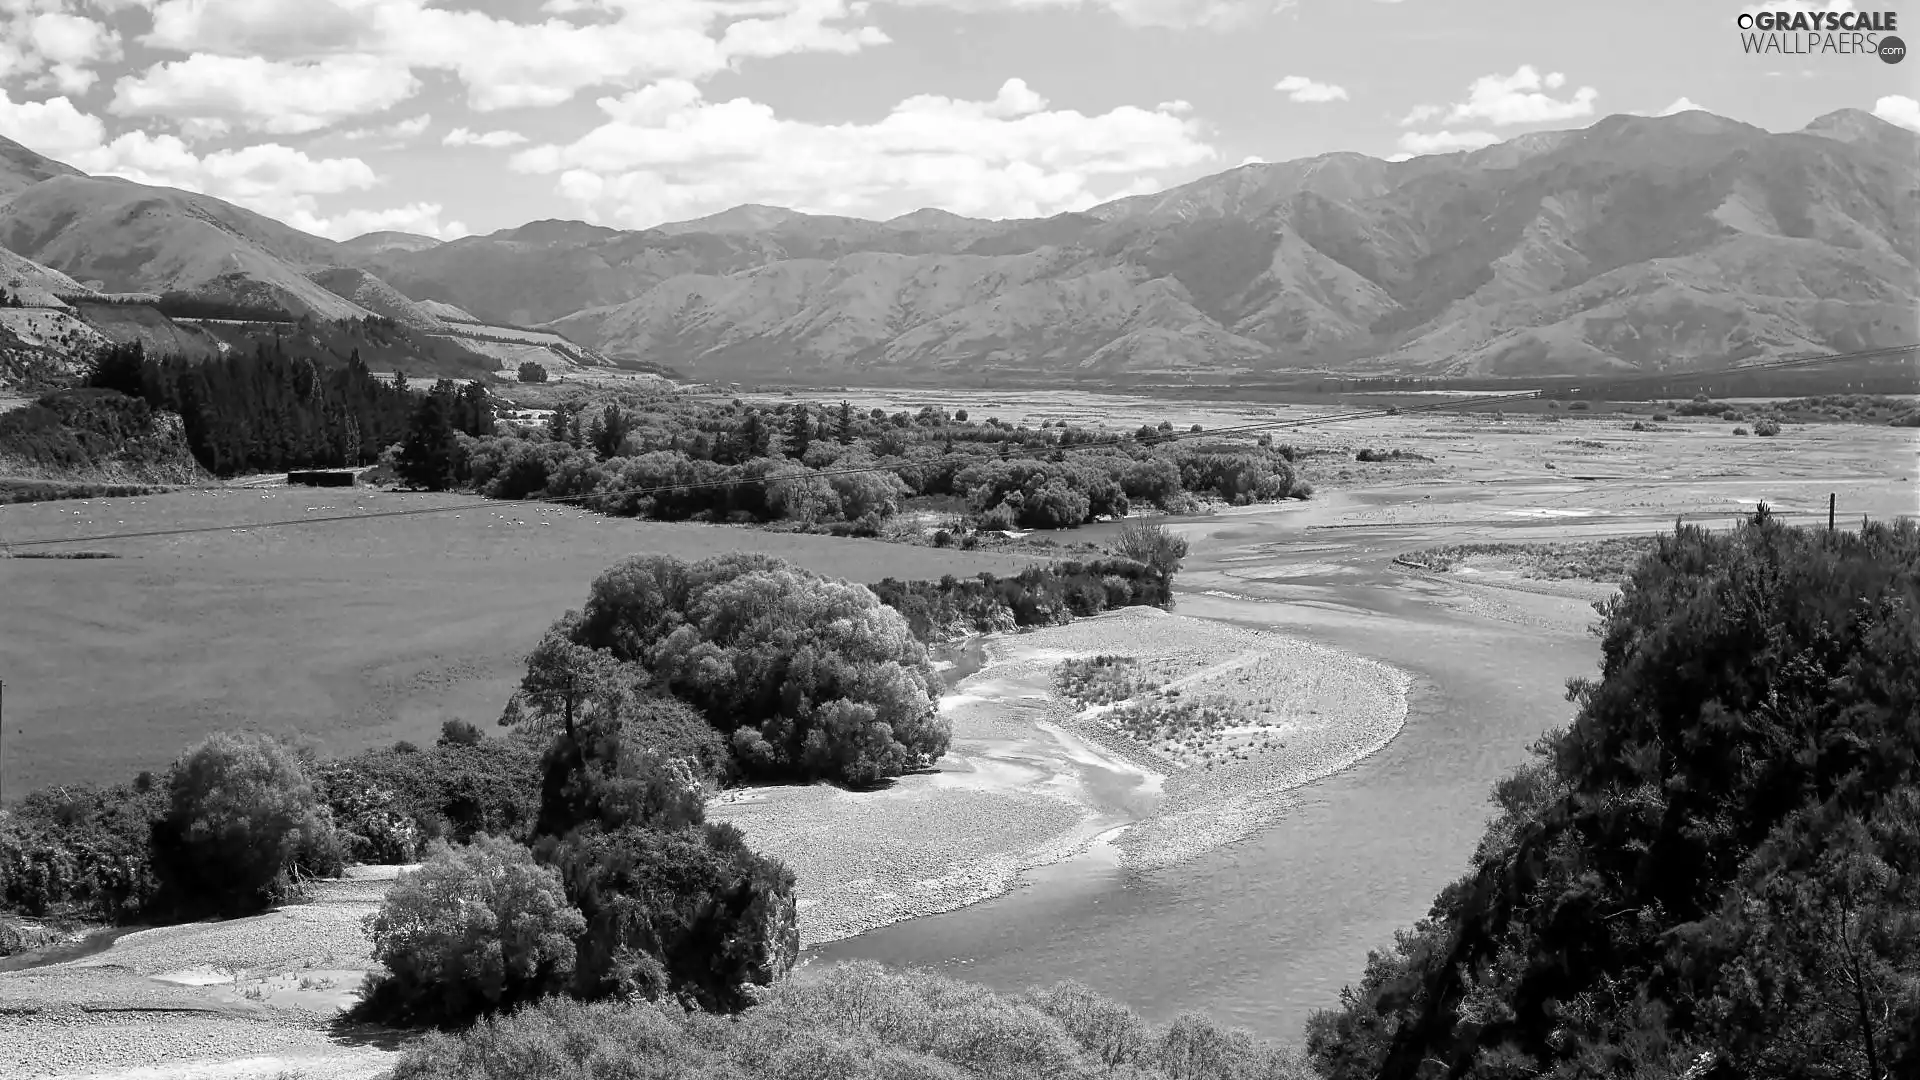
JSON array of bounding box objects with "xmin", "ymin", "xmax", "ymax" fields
[{"xmin": 154, "ymin": 732, "xmax": 346, "ymax": 915}]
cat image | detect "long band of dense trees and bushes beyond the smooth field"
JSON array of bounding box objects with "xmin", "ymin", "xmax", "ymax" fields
[{"xmin": 432, "ymin": 394, "xmax": 1309, "ymax": 534}]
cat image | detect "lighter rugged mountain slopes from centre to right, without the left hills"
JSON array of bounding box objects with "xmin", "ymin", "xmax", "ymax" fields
[{"xmin": 533, "ymin": 111, "xmax": 1920, "ymax": 379}]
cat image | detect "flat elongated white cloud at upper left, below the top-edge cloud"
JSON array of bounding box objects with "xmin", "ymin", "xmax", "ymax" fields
[{"xmin": 108, "ymin": 52, "xmax": 420, "ymax": 136}]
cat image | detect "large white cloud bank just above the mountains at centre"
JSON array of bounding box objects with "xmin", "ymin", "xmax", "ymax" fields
[{"xmin": 509, "ymin": 79, "xmax": 1215, "ymax": 227}]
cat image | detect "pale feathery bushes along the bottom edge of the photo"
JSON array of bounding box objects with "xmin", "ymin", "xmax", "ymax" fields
[{"xmin": 382, "ymin": 963, "xmax": 1311, "ymax": 1080}]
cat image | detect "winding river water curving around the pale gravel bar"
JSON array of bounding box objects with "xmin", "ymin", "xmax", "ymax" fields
[{"xmin": 810, "ymin": 496, "xmax": 1597, "ymax": 1040}]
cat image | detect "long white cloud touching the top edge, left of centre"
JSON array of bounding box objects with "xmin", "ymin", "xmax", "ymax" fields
[{"xmin": 144, "ymin": 0, "xmax": 887, "ymax": 111}]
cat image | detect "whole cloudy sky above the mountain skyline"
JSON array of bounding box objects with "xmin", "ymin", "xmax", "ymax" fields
[{"xmin": 0, "ymin": 0, "xmax": 1920, "ymax": 240}]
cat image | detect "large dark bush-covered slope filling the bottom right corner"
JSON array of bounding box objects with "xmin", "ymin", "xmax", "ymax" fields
[{"xmin": 1309, "ymin": 507, "xmax": 1920, "ymax": 1080}]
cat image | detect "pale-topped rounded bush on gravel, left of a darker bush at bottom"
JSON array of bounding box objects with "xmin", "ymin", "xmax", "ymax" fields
[{"xmin": 355, "ymin": 836, "xmax": 586, "ymax": 1026}]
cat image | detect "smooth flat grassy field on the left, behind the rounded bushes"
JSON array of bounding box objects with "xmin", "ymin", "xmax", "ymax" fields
[{"xmin": 0, "ymin": 488, "xmax": 1029, "ymax": 799}]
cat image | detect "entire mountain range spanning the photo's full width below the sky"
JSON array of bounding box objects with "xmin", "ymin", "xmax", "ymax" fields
[{"xmin": 0, "ymin": 110, "xmax": 1920, "ymax": 382}]
